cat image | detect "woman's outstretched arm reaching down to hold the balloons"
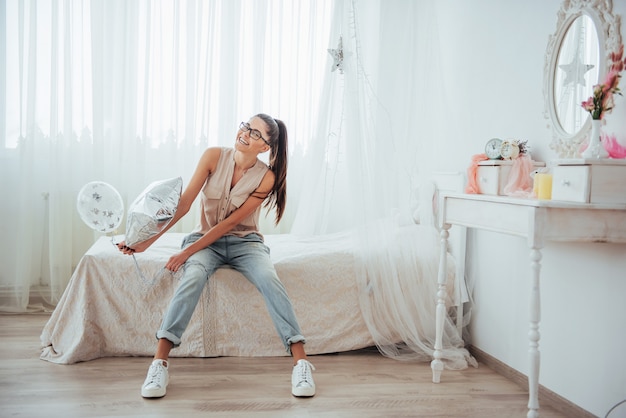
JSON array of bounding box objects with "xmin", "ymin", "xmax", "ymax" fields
[{"xmin": 118, "ymin": 148, "xmax": 221, "ymax": 254}]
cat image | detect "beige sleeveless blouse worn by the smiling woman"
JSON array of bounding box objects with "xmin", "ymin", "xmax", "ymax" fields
[{"xmin": 193, "ymin": 148, "xmax": 269, "ymax": 237}]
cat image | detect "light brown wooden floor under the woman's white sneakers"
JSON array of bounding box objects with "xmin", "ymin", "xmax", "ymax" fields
[{"xmin": 0, "ymin": 314, "xmax": 565, "ymax": 418}]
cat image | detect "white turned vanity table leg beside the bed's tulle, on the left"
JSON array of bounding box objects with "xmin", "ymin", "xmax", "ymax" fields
[{"xmin": 430, "ymin": 225, "xmax": 450, "ymax": 383}]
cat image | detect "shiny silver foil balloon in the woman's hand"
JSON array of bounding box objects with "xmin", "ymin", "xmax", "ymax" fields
[{"xmin": 125, "ymin": 177, "xmax": 183, "ymax": 248}]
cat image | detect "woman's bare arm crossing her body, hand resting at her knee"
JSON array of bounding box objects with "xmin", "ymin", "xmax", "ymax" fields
[{"xmin": 165, "ymin": 170, "xmax": 274, "ymax": 271}]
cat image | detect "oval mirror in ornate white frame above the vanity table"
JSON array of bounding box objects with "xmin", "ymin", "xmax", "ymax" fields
[{"xmin": 544, "ymin": 0, "xmax": 621, "ymax": 158}]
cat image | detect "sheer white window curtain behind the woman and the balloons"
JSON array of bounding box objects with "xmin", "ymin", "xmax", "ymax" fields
[{"xmin": 0, "ymin": 0, "xmax": 331, "ymax": 312}]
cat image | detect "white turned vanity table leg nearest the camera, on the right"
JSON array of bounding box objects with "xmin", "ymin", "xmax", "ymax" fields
[{"xmin": 527, "ymin": 248, "xmax": 541, "ymax": 418}]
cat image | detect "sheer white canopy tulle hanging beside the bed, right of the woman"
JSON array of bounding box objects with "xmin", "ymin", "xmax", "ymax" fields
[{"xmin": 292, "ymin": 0, "xmax": 475, "ymax": 368}]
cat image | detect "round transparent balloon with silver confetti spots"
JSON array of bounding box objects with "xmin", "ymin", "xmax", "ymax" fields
[{"xmin": 76, "ymin": 181, "xmax": 124, "ymax": 233}]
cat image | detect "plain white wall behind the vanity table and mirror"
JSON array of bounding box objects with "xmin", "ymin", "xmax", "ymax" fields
[{"xmin": 426, "ymin": 0, "xmax": 626, "ymax": 416}]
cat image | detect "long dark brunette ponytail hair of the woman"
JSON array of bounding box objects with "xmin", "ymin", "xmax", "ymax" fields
[{"xmin": 255, "ymin": 113, "xmax": 288, "ymax": 224}]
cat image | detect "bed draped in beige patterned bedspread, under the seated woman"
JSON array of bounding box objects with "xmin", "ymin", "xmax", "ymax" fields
[{"xmin": 40, "ymin": 171, "xmax": 464, "ymax": 364}]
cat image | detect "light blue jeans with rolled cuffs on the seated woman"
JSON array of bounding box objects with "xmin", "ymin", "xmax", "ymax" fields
[{"xmin": 156, "ymin": 233, "xmax": 305, "ymax": 352}]
